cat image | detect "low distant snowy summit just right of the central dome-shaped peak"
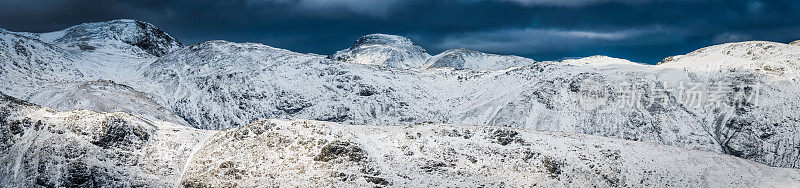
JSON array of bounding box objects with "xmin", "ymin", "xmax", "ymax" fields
[{"xmin": 424, "ymin": 49, "xmax": 535, "ymax": 71}]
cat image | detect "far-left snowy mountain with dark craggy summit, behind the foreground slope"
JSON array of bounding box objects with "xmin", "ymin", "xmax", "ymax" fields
[{"xmin": 0, "ymin": 20, "xmax": 185, "ymax": 124}]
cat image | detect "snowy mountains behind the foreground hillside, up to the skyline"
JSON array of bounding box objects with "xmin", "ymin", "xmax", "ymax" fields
[{"xmin": 0, "ymin": 20, "xmax": 800, "ymax": 172}]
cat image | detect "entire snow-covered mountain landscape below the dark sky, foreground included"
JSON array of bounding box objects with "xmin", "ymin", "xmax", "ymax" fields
[{"xmin": 0, "ymin": 20, "xmax": 800, "ymax": 187}]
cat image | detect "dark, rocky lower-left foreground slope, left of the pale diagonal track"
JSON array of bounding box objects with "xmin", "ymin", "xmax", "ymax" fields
[{"xmin": 0, "ymin": 94, "xmax": 209, "ymax": 187}]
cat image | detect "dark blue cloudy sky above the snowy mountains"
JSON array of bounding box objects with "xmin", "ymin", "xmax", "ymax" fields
[{"xmin": 0, "ymin": 0, "xmax": 800, "ymax": 63}]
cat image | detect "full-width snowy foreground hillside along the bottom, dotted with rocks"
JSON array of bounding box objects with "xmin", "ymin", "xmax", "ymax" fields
[{"xmin": 0, "ymin": 94, "xmax": 800, "ymax": 187}]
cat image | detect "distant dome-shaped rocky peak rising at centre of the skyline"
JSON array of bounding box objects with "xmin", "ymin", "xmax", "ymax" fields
[{"xmin": 331, "ymin": 34, "xmax": 430, "ymax": 69}]
